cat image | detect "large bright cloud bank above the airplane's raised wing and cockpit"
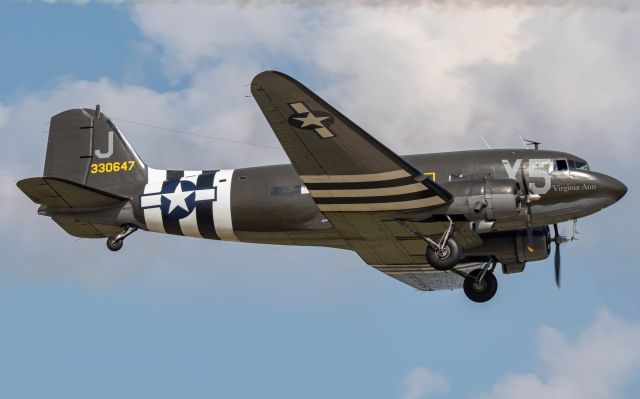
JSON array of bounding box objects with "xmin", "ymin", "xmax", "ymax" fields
[{"xmin": 133, "ymin": 3, "xmax": 640, "ymax": 158}]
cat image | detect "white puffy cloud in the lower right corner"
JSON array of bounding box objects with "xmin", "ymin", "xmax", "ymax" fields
[{"xmin": 479, "ymin": 310, "xmax": 640, "ymax": 399}]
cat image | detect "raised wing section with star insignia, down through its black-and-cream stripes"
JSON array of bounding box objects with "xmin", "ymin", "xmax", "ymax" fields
[{"xmin": 251, "ymin": 71, "xmax": 452, "ymax": 216}]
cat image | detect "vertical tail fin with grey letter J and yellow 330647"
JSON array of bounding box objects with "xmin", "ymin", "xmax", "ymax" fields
[{"xmin": 44, "ymin": 107, "xmax": 146, "ymax": 196}]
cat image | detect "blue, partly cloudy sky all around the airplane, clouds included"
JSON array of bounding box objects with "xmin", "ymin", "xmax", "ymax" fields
[{"xmin": 0, "ymin": 0, "xmax": 640, "ymax": 399}]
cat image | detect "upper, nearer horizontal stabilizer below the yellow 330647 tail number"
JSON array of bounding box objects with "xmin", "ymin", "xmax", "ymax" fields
[{"xmin": 17, "ymin": 177, "xmax": 127, "ymax": 209}]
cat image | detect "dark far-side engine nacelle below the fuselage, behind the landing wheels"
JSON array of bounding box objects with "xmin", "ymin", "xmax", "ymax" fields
[{"xmin": 465, "ymin": 226, "xmax": 551, "ymax": 272}]
